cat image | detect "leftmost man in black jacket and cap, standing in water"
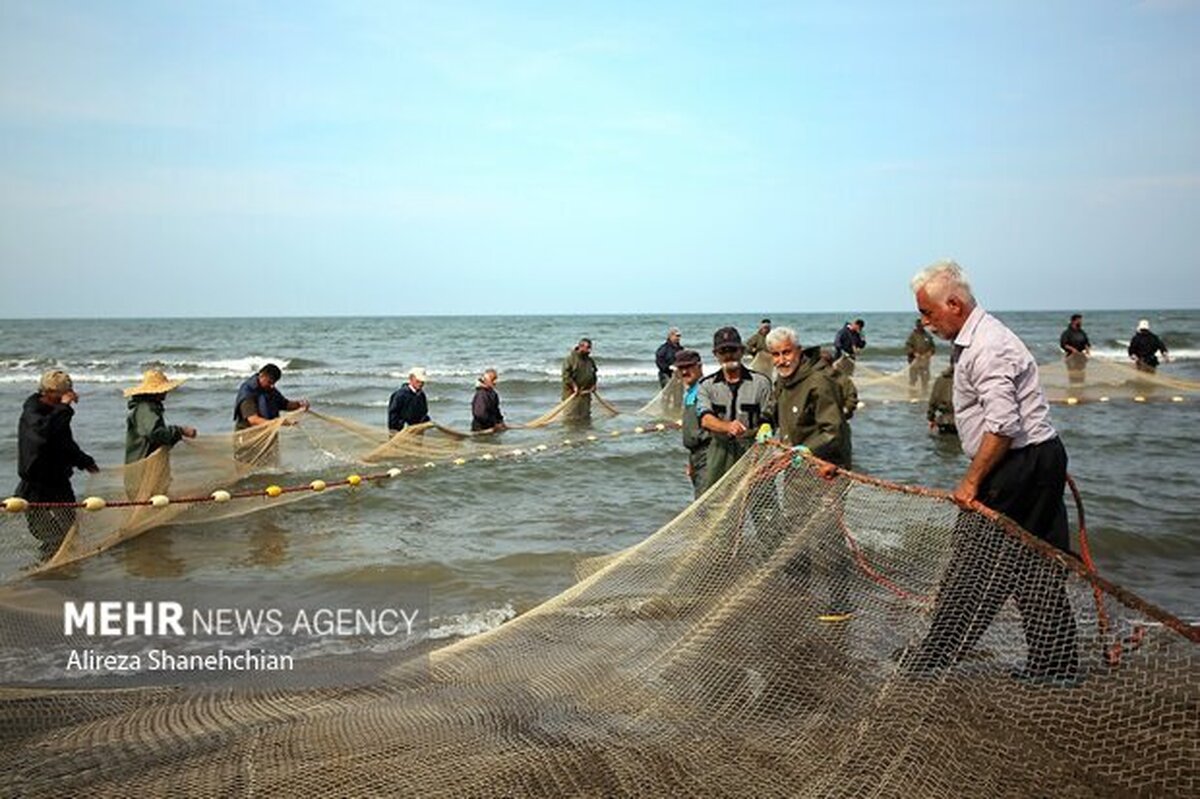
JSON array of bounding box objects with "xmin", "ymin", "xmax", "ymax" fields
[{"xmin": 16, "ymin": 370, "xmax": 100, "ymax": 558}]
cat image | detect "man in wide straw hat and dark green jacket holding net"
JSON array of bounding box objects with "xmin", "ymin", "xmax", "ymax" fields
[{"xmin": 125, "ymin": 370, "xmax": 196, "ymax": 499}]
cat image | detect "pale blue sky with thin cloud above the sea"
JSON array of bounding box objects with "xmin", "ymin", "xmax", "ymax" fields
[{"xmin": 0, "ymin": 0, "xmax": 1200, "ymax": 318}]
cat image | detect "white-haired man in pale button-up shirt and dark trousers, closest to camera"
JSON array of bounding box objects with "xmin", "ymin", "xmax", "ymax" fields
[{"xmin": 902, "ymin": 260, "xmax": 1079, "ymax": 681}]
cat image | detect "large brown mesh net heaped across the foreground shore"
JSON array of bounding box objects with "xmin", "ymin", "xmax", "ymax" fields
[{"xmin": 0, "ymin": 446, "xmax": 1200, "ymax": 797}]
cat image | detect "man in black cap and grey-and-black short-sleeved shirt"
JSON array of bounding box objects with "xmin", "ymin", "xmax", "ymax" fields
[{"xmin": 696, "ymin": 328, "xmax": 770, "ymax": 489}]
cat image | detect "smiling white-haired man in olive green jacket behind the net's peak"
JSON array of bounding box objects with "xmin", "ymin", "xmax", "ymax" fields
[{"xmin": 767, "ymin": 328, "xmax": 851, "ymax": 469}]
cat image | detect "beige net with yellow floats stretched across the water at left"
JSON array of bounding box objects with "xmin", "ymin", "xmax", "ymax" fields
[{"xmin": 0, "ymin": 385, "xmax": 657, "ymax": 582}]
